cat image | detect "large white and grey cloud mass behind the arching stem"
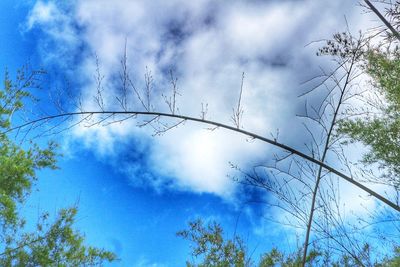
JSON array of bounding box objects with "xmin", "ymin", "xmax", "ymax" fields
[{"xmin": 27, "ymin": 0, "xmax": 388, "ymax": 215}]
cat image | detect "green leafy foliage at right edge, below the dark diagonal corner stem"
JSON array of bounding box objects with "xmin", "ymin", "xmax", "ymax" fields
[{"xmin": 339, "ymin": 51, "xmax": 400, "ymax": 181}]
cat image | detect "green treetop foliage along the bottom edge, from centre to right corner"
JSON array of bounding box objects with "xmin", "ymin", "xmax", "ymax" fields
[{"xmin": 177, "ymin": 219, "xmax": 400, "ymax": 267}]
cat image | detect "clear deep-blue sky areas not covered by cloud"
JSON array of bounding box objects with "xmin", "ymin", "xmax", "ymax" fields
[{"xmin": 0, "ymin": 1, "xmax": 276, "ymax": 266}]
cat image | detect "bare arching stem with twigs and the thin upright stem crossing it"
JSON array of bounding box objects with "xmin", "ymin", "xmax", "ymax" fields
[{"xmin": 6, "ymin": 1, "xmax": 400, "ymax": 266}]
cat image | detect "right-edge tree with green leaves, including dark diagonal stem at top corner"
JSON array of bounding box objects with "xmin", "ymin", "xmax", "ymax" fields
[{"xmin": 332, "ymin": 0, "xmax": 400, "ymax": 194}]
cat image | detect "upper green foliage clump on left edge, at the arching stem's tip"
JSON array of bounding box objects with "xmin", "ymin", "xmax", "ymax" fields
[{"xmin": 0, "ymin": 67, "xmax": 56, "ymax": 237}]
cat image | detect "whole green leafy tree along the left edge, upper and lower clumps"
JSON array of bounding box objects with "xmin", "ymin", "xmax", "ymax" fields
[{"xmin": 0, "ymin": 66, "xmax": 116, "ymax": 266}]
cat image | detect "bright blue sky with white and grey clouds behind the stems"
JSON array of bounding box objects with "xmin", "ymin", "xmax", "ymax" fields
[{"xmin": 0, "ymin": 0, "xmax": 394, "ymax": 266}]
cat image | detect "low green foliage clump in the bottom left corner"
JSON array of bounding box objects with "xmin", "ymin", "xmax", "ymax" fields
[{"xmin": 0, "ymin": 208, "xmax": 115, "ymax": 266}]
